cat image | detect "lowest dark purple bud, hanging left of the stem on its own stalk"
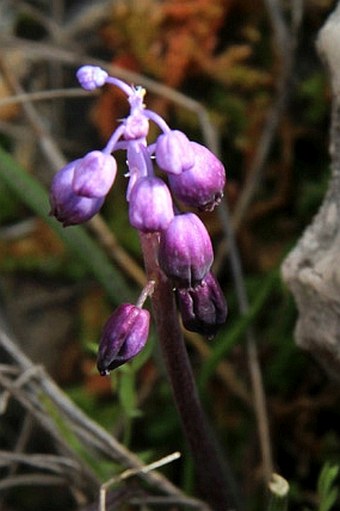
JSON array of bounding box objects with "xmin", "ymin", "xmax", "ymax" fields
[{"xmin": 97, "ymin": 303, "xmax": 150, "ymax": 376}]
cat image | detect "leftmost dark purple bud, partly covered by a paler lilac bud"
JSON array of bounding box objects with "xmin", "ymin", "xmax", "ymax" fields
[{"xmin": 50, "ymin": 160, "xmax": 104, "ymax": 227}]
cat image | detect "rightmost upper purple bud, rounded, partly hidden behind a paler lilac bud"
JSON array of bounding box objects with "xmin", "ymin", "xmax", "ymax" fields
[{"xmin": 169, "ymin": 142, "xmax": 226, "ymax": 211}]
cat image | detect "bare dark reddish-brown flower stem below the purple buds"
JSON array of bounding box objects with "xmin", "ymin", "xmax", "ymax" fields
[{"xmin": 141, "ymin": 234, "xmax": 233, "ymax": 511}]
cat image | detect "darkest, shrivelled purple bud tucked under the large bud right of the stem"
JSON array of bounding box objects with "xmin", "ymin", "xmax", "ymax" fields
[{"xmin": 177, "ymin": 272, "xmax": 227, "ymax": 338}]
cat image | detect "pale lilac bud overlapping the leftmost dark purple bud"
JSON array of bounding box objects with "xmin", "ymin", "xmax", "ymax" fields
[{"xmin": 72, "ymin": 151, "xmax": 117, "ymax": 198}]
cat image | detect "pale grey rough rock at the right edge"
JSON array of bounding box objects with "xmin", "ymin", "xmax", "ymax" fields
[{"xmin": 282, "ymin": 2, "xmax": 340, "ymax": 381}]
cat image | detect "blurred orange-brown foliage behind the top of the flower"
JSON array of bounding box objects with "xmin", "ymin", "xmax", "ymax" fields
[{"xmin": 93, "ymin": 0, "xmax": 268, "ymax": 139}]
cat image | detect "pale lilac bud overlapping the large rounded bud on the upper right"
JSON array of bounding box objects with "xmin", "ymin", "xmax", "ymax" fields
[{"xmin": 155, "ymin": 130, "xmax": 195, "ymax": 175}]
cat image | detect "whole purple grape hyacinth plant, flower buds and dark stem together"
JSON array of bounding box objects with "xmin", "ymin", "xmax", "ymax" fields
[{"xmin": 50, "ymin": 65, "xmax": 230, "ymax": 510}]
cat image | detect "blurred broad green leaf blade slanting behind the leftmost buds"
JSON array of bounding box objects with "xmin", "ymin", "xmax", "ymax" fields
[{"xmin": 0, "ymin": 147, "xmax": 132, "ymax": 303}]
